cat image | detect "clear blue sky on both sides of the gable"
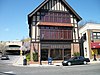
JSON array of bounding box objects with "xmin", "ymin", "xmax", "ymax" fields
[{"xmin": 0, "ymin": 0, "xmax": 100, "ymax": 41}]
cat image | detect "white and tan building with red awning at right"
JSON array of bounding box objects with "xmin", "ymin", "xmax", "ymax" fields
[{"xmin": 79, "ymin": 23, "xmax": 100, "ymax": 59}]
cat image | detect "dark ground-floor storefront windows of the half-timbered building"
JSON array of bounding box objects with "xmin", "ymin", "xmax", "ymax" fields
[{"xmin": 41, "ymin": 49, "xmax": 71, "ymax": 61}]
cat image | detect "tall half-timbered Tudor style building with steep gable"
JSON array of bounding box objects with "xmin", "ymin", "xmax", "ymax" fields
[{"xmin": 28, "ymin": 0, "xmax": 81, "ymax": 63}]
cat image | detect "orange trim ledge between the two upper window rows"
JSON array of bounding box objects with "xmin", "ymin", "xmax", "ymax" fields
[{"xmin": 38, "ymin": 22, "xmax": 72, "ymax": 27}]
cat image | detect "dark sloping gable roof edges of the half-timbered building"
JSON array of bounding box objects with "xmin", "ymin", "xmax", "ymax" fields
[{"xmin": 28, "ymin": 0, "xmax": 82, "ymax": 21}]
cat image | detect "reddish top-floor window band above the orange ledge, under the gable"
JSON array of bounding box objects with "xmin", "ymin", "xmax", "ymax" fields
[{"xmin": 41, "ymin": 12, "xmax": 71, "ymax": 23}]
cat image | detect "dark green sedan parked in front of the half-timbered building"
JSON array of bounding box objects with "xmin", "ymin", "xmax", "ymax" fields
[{"xmin": 62, "ymin": 56, "xmax": 90, "ymax": 66}]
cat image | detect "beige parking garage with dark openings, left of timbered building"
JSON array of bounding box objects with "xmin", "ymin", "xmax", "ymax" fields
[{"xmin": 0, "ymin": 40, "xmax": 22, "ymax": 54}]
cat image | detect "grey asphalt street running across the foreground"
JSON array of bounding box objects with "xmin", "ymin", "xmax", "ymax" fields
[{"xmin": 0, "ymin": 63, "xmax": 100, "ymax": 75}]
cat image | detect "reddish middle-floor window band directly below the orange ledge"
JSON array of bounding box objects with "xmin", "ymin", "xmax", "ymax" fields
[{"xmin": 40, "ymin": 27, "xmax": 72, "ymax": 40}]
